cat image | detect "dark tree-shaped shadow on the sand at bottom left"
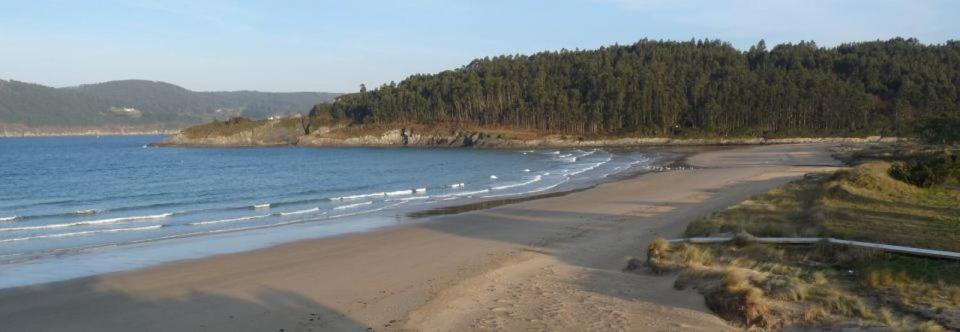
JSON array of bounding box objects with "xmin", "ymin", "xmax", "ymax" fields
[{"xmin": 0, "ymin": 278, "xmax": 370, "ymax": 331}]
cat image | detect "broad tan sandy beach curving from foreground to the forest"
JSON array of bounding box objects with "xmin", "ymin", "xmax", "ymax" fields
[{"xmin": 0, "ymin": 144, "xmax": 837, "ymax": 331}]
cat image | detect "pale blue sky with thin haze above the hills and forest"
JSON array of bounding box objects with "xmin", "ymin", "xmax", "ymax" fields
[{"xmin": 0, "ymin": 0, "xmax": 960, "ymax": 92}]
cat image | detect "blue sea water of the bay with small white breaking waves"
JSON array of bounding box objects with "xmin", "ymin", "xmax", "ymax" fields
[{"xmin": 0, "ymin": 136, "xmax": 654, "ymax": 287}]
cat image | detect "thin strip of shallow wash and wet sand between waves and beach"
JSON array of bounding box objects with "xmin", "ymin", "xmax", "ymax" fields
[{"xmin": 0, "ymin": 148, "xmax": 660, "ymax": 290}]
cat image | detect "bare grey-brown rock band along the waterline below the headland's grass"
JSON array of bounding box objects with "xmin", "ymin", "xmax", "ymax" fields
[{"xmin": 158, "ymin": 126, "xmax": 896, "ymax": 148}]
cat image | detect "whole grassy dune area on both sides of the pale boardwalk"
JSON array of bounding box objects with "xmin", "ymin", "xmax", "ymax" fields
[{"xmin": 630, "ymin": 152, "xmax": 960, "ymax": 331}]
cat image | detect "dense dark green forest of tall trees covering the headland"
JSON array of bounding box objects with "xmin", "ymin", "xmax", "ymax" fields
[{"xmin": 311, "ymin": 39, "xmax": 960, "ymax": 136}]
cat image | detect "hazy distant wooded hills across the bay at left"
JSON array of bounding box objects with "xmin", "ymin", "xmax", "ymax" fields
[{"xmin": 0, "ymin": 80, "xmax": 338, "ymax": 130}]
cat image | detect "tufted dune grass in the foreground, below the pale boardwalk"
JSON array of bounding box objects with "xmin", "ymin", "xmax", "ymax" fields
[{"xmin": 646, "ymin": 242, "xmax": 960, "ymax": 331}]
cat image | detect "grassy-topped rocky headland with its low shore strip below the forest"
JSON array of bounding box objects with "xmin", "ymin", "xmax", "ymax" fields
[{"xmin": 155, "ymin": 117, "xmax": 897, "ymax": 148}]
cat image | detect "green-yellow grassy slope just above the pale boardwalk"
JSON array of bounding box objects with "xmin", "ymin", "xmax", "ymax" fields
[{"xmin": 687, "ymin": 162, "xmax": 960, "ymax": 251}]
